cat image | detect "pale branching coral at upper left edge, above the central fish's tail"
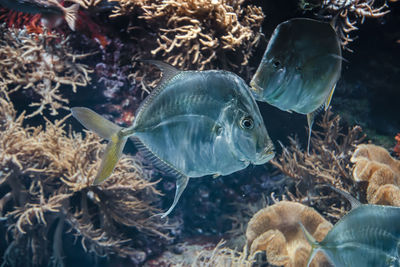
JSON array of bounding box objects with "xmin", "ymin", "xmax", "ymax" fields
[{"xmin": 0, "ymin": 25, "xmax": 91, "ymax": 116}]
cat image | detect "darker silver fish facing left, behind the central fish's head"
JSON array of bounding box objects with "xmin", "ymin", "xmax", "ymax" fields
[{"xmin": 250, "ymin": 18, "xmax": 342, "ymax": 154}]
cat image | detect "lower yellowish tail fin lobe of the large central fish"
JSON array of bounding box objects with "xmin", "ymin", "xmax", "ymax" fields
[{"xmin": 93, "ymin": 133, "xmax": 127, "ymax": 185}]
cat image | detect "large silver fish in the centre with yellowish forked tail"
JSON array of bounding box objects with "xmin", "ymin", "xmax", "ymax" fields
[{"xmin": 72, "ymin": 61, "xmax": 274, "ymax": 217}]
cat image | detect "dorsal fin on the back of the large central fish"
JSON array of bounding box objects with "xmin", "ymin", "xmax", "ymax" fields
[{"xmin": 135, "ymin": 60, "xmax": 181, "ymax": 124}]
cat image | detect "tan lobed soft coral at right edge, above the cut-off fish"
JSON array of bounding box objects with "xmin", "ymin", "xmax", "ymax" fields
[{"xmin": 351, "ymin": 144, "xmax": 400, "ymax": 206}]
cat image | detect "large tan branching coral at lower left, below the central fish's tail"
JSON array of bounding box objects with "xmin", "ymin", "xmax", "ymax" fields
[{"xmin": 0, "ymin": 95, "xmax": 172, "ymax": 266}]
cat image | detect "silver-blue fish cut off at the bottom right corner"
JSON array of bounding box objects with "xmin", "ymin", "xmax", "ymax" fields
[{"xmin": 303, "ymin": 205, "xmax": 400, "ymax": 267}]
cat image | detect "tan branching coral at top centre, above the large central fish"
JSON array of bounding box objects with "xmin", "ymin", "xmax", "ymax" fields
[{"xmin": 113, "ymin": 0, "xmax": 264, "ymax": 70}]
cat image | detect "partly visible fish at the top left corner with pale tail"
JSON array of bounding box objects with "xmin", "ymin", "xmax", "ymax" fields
[{"xmin": 0, "ymin": 0, "xmax": 79, "ymax": 30}]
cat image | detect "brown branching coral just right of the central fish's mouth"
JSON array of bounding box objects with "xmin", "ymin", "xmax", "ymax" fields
[{"xmin": 271, "ymin": 110, "xmax": 365, "ymax": 220}]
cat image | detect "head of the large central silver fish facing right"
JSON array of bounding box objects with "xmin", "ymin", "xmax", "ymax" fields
[{"xmin": 224, "ymin": 75, "xmax": 275, "ymax": 165}]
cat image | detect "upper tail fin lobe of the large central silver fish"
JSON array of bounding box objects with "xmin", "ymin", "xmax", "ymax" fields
[{"xmin": 71, "ymin": 107, "xmax": 122, "ymax": 140}]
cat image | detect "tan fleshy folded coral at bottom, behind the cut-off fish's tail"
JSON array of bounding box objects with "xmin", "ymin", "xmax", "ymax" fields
[{"xmin": 246, "ymin": 201, "xmax": 332, "ymax": 267}]
